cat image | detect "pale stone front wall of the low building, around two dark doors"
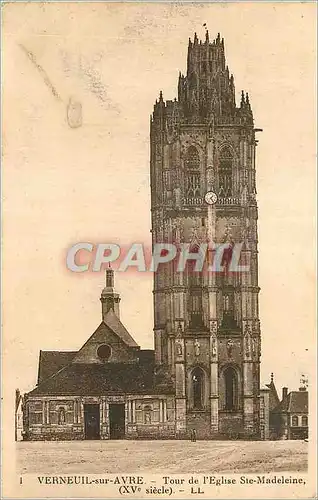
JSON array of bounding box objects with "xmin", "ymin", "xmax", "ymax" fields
[{"xmin": 24, "ymin": 395, "xmax": 175, "ymax": 441}]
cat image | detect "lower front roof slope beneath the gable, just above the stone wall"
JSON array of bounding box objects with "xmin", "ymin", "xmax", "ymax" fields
[{"xmin": 28, "ymin": 363, "xmax": 173, "ymax": 396}]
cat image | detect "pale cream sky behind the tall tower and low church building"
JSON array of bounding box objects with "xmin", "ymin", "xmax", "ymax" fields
[{"xmin": 3, "ymin": 3, "xmax": 316, "ymax": 398}]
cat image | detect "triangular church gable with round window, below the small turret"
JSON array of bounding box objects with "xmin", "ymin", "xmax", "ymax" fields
[{"xmin": 73, "ymin": 320, "xmax": 139, "ymax": 364}]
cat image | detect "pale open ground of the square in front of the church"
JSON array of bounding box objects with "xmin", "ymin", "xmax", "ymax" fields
[{"xmin": 16, "ymin": 440, "xmax": 308, "ymax": 474}]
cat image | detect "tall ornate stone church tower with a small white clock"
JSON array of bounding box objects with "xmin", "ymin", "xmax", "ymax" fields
[{"xmin": 151, "ymin": 32, "xmax": 260, "ymax": 438}]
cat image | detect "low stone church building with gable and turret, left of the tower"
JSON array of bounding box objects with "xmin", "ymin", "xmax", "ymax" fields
[{"xmin": 24, "ymin": 269, "xmax": 175, "ymax": 440}]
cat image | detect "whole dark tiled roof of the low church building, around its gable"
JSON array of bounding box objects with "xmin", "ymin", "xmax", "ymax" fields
[{"xmin": 28, "ymin": 311, "xmax": 159, "ymax": 396}]
